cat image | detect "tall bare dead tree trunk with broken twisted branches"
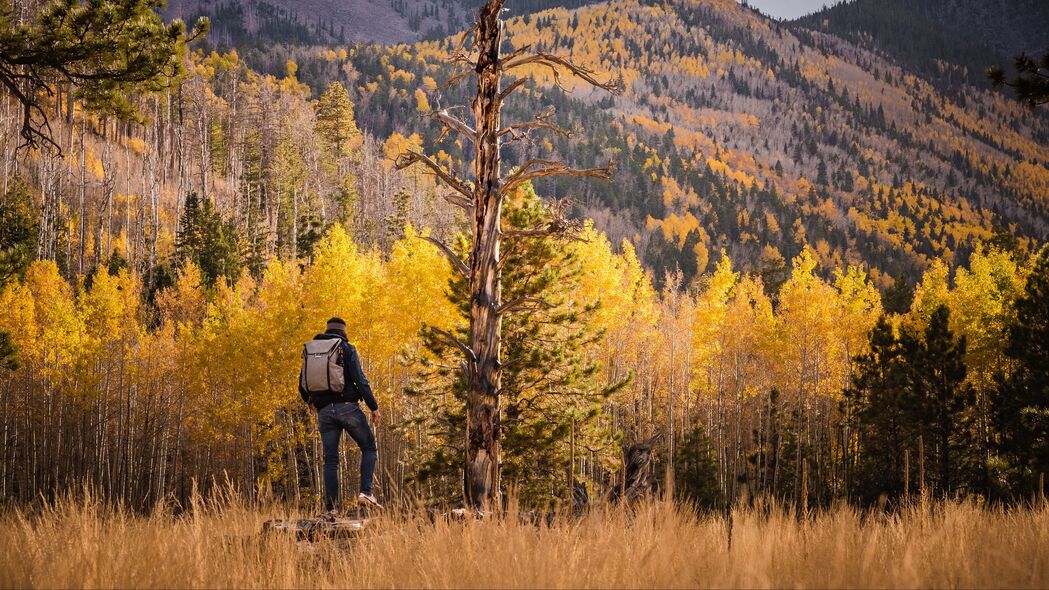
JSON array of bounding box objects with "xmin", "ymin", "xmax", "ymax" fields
[{"xmin": 398, "ymin": 0, "xmax": 620, "ymax": 508}]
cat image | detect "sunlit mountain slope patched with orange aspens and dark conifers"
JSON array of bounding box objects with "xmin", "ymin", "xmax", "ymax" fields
[{"xmin": 167, "ymin": 0, "xmax": 1049, "ymax": 286}]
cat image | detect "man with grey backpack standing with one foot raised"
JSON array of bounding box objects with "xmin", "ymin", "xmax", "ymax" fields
[{"xmin": 299, "ymin": 317, "xmax": 381, "ymax": 513}]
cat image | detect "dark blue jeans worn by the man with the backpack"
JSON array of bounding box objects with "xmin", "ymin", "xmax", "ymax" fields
[{"xmin": 317, "ymin": 402, "xmax": 379, "ymax": 510}]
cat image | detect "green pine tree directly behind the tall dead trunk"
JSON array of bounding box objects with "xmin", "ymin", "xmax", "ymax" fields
[{"xmin": 409, "ymin": 185, "xmax": 625, "ymax": 506}]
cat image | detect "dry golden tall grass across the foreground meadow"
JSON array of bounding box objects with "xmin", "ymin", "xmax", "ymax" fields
[{"xmin": 0, "ymin": 491, "xmax": 1049, "ymax": 588}]
